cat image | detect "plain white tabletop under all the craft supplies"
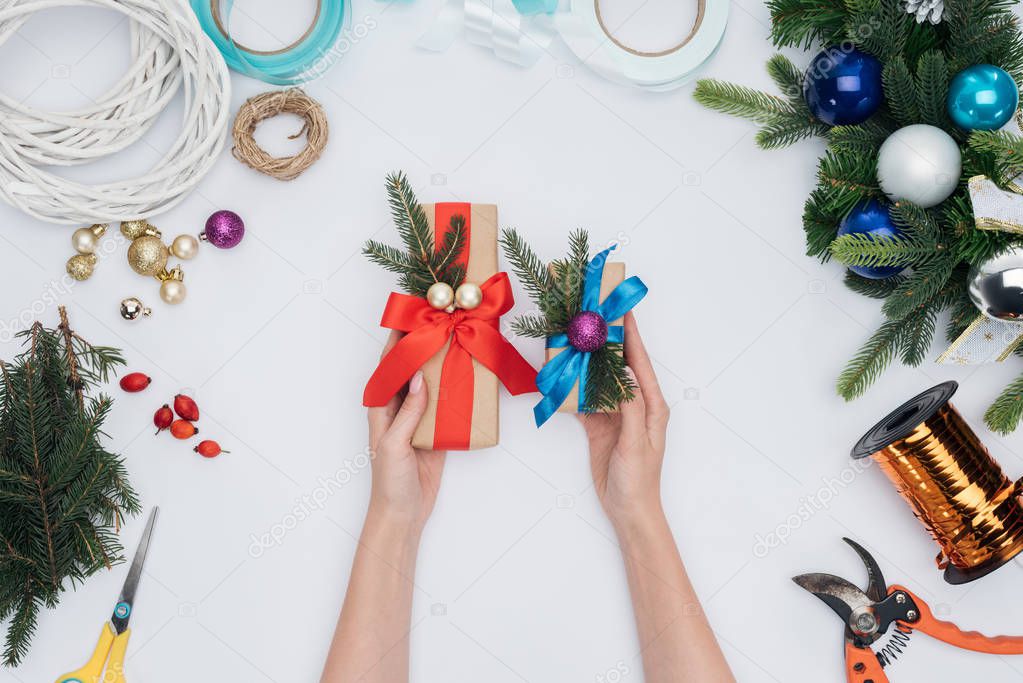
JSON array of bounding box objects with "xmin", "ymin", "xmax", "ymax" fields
[{"xmin": 0, "ymin": 0, "xmax": 1023, "ymax": 683}]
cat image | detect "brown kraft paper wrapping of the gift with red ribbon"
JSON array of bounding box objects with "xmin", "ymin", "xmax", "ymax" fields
[{"xmin": 412, "ymin": 203, "xmax": 500, "ymax": 450}]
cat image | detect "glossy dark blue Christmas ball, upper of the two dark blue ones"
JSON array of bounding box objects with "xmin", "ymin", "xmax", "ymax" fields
[{"xmin": 803, "ymin": 46, "xmax": 884, "ymax": 126}]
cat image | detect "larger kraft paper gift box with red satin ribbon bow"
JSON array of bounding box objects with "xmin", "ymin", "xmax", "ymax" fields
[{"xmin": 363, "ymin": 202, "xmax": 537, "ymax": 450}]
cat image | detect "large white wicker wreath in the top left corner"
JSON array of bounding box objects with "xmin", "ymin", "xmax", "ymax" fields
[{"xmin": 0, "ymin": 0, "xmax": 230, "ymax": 225}]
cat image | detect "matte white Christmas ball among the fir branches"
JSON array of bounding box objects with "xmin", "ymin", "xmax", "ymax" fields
[{"xmin": 878, "ymin": 124, "xmax": 963, "ymax": 209}]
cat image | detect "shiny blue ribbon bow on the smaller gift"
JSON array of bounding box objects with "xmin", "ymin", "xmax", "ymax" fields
[{"xmin": 533, "ymin": 246, "xmax": 647, "ymax": 426}]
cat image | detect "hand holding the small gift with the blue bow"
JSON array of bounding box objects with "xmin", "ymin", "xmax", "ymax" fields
[{"xmin": 579, "ymin": 313, "xmax": 668, "ymax": 534}]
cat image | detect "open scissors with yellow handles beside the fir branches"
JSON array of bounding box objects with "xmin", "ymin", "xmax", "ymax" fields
[{"xmin": 56, "ymin": 507, "xmax": 160, "ymax": 683}]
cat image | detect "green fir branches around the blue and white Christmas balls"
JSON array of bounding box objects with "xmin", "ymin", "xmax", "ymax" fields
[{"xmin": 695, "ymin": 0, "xmax": 1023, "ymax": 431}]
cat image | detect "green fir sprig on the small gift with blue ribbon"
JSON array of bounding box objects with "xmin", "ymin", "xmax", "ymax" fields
[{"xmin": 500, "ymin": 229, "xmax": 636, "ymax": 412}]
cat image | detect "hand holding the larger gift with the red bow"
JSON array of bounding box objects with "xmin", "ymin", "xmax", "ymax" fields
[{"xmin": 367, "ymin": 332, "xmax": 446, "ymax": 534}]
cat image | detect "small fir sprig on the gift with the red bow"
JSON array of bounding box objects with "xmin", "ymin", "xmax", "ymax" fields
[{"xmin": 362, "ymin": 172, "xmax": 465, "ymax": 297}]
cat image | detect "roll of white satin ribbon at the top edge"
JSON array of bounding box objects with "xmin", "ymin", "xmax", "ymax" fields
[{"xmin": 554, "ymin": 0, "xmax": 728, "ymax": 90}]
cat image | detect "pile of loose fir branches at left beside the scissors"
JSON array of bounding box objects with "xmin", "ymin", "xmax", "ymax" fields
[{"xmin": 0, "ymin": 307, "xmax": 139, "ymax": 666}]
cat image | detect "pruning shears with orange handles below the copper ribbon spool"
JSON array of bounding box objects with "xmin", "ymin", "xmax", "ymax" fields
[{"xmin": 792, "ymin": 539, "xmax": 1023, "ymax": 683}]
